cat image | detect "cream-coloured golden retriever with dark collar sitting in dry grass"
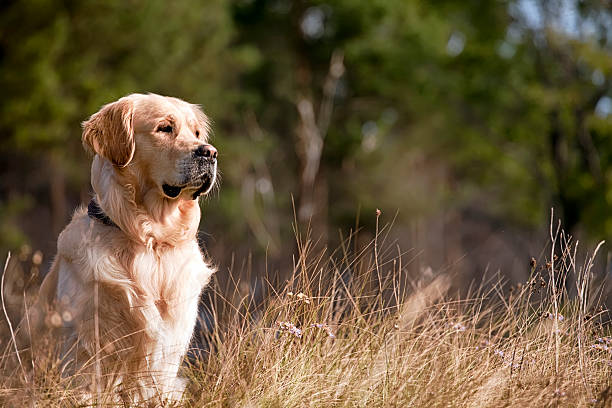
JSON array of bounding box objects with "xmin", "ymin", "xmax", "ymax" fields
[{"xmin": 20, "ymin": 94, "xmax": 217, "ymax": 404}]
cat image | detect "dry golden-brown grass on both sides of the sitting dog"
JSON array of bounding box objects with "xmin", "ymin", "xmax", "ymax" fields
[{"xmin": 0, "ymin": 215, "xmax": 612, "ymax": 407}]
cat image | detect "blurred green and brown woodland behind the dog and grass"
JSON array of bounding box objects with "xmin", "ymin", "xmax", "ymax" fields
[{"xmin": 0, "ymin": 0, "xmax": 612, "ymax": 294}]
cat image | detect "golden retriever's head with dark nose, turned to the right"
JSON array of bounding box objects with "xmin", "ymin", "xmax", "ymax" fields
[{"xmin": 83, "ymin": 94, "xmax": 217, "ymax": 199}]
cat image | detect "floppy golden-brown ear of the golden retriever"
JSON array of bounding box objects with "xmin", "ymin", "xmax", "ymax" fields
[{"xmin": 83, "ymin": 98, "xmax": 136, "ymax": 167}]
